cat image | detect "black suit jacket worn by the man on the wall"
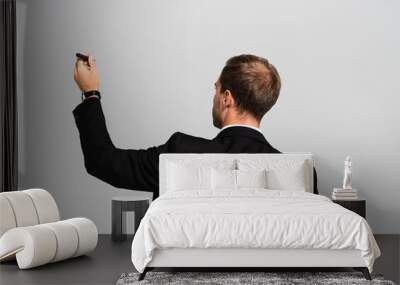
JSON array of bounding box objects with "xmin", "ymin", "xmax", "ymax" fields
[{"xmin": 72, "ymin": 98, "xmax": 318, "ymax": 199}]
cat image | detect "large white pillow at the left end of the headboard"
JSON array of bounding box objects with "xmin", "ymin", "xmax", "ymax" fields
[{"xmin": 166, "ymin": 161, "xmax": 211, "ymax": 191}]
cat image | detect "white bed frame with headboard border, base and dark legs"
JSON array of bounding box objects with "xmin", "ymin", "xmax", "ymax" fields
[{"xmin": 138, "ymin": 153, "xmax": 371, "ymax": 280}]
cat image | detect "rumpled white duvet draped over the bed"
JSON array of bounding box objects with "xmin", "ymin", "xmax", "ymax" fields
[{"xmin": 131, "ymin": 189, "xmax": 380, "ymax": 272}]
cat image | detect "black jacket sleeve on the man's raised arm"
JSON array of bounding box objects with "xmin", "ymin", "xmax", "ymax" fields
[{"xmin": 72, "ymin": 98, "xmax": 174, "ymax": 193}]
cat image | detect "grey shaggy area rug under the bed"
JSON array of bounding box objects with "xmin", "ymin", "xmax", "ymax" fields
[{"xmin": 116, "ymin": 271, "xmax": 395, "ymax": 285}]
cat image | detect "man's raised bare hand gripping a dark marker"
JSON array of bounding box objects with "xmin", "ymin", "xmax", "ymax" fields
[{"xmin": 74, "ymin": 54, "xmax": 100, "ymax": 92}]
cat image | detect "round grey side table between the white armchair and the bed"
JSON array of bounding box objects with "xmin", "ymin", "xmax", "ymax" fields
[{"xmin": 111, "ymin": 196, "xmax": 152, "ymax": 241}]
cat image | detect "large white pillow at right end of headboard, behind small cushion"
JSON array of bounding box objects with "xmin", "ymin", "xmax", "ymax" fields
[{"xmin": 237, "ymin": 159, "xmax": 308, "ymax": 192}]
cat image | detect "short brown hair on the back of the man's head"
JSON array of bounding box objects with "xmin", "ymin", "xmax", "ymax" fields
[{"xmin": 219, "ymin": 54, "xmax": 281, "ymax": 121}]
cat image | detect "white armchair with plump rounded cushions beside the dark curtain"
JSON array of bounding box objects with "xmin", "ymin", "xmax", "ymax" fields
[{"xmin": 0, "ymin": 189, "xmax": 98, "ymax": 269}]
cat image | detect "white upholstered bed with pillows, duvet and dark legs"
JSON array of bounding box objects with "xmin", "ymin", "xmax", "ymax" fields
[{"xmin": 131, "ymin": 153, "xmax": 381, "ymax": 280}]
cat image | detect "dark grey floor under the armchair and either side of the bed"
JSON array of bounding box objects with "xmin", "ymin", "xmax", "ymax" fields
[{"xmin": 0, "ymin": 235, "xmax": 400, "ymax": 285}]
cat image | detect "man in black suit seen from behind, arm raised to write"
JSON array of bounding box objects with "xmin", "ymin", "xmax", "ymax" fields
[{"xmin": 72, "ymin": 54, "xmax": 318, "ymax": 199}]
